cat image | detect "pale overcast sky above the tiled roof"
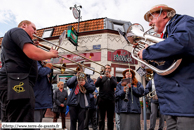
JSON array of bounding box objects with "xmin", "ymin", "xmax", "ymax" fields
[{"xmin": 0, "ymin": 0, "xmax": 194, "ymax": 37}]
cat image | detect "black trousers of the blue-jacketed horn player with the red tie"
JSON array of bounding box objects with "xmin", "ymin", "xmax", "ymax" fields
[{"xmin": 69, "ymin": 105, "xmax": 85, "ymax": 130}]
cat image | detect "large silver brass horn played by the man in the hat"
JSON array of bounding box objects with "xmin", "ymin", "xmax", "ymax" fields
[{"xmin": 118, "ymin": 23, "xmax": 182, "ymax": 75}]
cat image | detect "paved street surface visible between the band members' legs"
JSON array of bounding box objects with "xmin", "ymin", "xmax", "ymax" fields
[{"xmin": 42, "ymin": 117, "xmax": 166, "ymax": 130}]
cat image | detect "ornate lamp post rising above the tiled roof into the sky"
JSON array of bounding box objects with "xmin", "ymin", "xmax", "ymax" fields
[{"xmin": 69, "ymin": 4, "xmax": 82, "ymax": 50}]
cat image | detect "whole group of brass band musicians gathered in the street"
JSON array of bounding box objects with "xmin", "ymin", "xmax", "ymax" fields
[{"xmin": 0, "ymin": 2, "xmax": 194, "ymax": 130}]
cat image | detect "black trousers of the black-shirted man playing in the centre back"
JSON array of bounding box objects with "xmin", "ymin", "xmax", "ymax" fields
[{"xmin": 98, "ymin": 97, "xmax": 115, "ymax": 130}]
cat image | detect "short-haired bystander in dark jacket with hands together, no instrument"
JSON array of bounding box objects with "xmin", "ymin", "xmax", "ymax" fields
[{"xmin": 52, "ymin": 81, "xmax": 68, "ymax": 130}]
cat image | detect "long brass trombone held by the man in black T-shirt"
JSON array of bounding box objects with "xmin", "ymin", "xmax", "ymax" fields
[{"xmin": 33, "ymin": 34, "xmax": 105, "ymax": 75}]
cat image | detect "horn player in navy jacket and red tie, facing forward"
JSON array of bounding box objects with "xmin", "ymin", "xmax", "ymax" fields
[{"xmin": 67, "ymin": 66, "xmax": 95, "ymax": 130}]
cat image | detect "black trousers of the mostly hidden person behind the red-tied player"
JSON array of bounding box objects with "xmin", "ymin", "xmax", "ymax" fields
[{"xmin": 84, "ymin": 108, "xmax": 97, "ymax": 130}]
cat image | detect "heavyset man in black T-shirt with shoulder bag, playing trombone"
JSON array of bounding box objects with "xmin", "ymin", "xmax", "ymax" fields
[{"xmin": 0, "ymin": 20, "xmax": 58, "ymax": 122}]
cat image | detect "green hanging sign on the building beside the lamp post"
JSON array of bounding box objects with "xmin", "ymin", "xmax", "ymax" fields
[{"xmin": 67, "ymin": 26, "xmax": 78, "ymax": 46}]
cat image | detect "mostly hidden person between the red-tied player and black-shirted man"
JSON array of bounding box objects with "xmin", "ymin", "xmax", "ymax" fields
[{"xmin": 84, "ymin": 78, "xmax": 98, "ymax": 130}]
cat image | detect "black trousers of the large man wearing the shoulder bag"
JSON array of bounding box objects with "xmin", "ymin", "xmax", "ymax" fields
[{"xmin": 0, "ymin": 87, "xmax": 35, "ymax": 122}]
